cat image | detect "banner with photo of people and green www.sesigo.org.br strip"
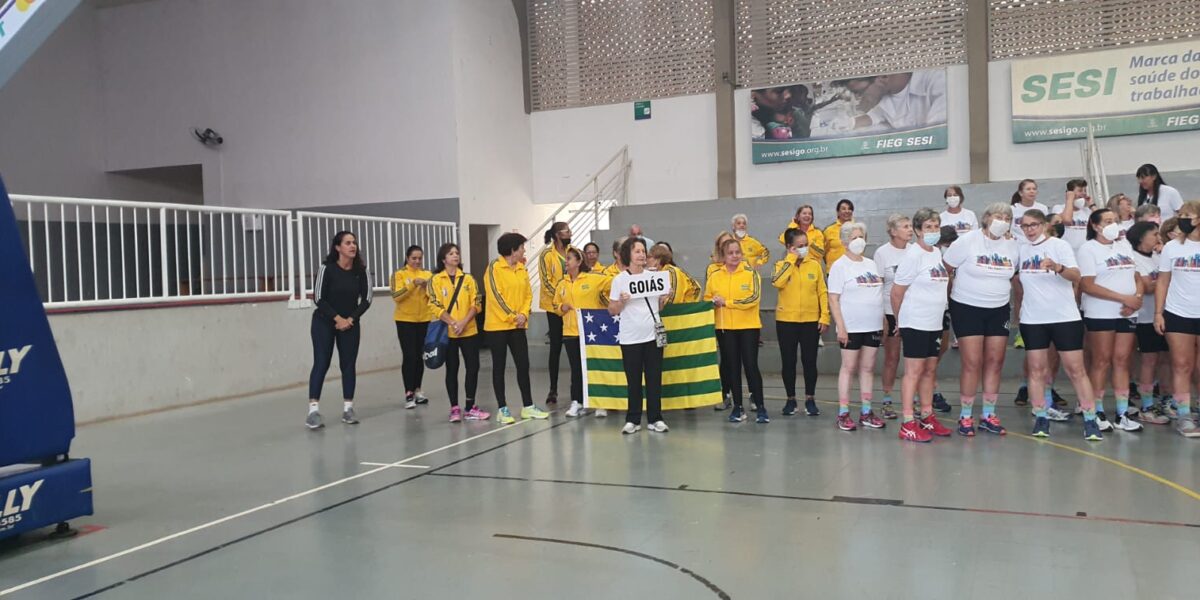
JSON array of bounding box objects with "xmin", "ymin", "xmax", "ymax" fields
[{"xmin": 750, "ymin": 68, "xmax": 947, "ymax": 164}]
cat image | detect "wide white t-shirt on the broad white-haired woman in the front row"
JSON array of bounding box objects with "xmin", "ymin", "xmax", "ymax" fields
[{"xmin": 943, "ymin": 229, "xmax": 1020, "ymax": 308}]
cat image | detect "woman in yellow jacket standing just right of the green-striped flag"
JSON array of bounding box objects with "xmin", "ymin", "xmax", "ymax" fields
[{"xmin": 704, "ymin": 240, "xmax": 770, "ymax": 424}]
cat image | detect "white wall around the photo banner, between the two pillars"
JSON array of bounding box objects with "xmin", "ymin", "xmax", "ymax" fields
[{"xmin": 733, "ymin": 65, "xmax": 971, "ymax": 198}]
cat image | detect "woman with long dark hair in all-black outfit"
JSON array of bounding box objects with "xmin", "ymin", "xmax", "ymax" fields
[{"xmin": 305, "ymin": 232, "xmax": 371, "ymax": 430}]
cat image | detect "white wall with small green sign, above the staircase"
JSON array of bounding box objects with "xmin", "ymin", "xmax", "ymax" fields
[{"xmin": 530, "ymin": 94, "xmax": 715, "ymax": 204}]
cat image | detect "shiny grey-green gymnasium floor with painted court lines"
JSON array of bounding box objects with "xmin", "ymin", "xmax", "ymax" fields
[{"xmin": 0, "ymin": 371, "xmax": 1200, "ymax": 600}]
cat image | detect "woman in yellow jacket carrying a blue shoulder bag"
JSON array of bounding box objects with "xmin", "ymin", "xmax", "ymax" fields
[{"xmin": 430, "ymin": 244, "xmax": 491, "ymax": 422}]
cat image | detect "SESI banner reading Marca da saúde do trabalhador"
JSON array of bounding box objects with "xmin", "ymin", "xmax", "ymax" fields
[{"xmin": 1012, "ymin": 41, "xmax": 1200, "ymax": 144}]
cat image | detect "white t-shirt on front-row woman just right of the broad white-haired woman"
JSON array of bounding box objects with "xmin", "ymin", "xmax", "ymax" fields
[{"xmin": 1019, "ymin": 238, "xmax": 1080, "ymax": 325}]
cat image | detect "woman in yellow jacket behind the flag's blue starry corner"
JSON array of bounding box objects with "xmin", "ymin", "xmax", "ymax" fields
[{"xmin": 553, "ymin": 248, "xmax": 612, "ymax": 416}]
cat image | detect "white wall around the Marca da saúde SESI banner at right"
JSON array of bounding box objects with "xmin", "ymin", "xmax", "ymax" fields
[{"xmin": 988, "ymin": 60, "xmax": 1200, "ymax": 181}]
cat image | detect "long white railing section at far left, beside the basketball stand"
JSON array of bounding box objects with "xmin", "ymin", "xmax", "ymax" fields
[{"xmin": 11, "ymin": 194, "xmax": 295, "ymax": 308}]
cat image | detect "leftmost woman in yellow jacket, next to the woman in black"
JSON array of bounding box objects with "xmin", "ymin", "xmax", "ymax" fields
[{"xmin": 391, "ymin": 246, "xmax": 433, "ymax": 408}]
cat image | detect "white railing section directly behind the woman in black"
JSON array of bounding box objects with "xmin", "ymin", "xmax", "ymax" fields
[{"xmin": 296, "ymin": 211, "xmax": 458, "ymax": 306}]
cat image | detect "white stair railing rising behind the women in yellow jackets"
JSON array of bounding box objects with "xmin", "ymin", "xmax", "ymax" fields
[{"xmin": 526, "ymin": 146, "xmax": 630, "ymax": 306}]
